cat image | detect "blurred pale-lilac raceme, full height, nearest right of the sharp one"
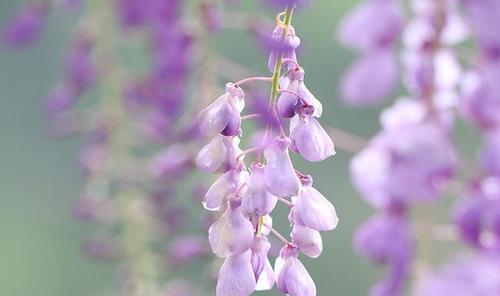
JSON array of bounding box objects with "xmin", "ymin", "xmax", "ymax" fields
[{"xmin": 351, "ymin": 0, "xmax": 460, "ymax": 295}]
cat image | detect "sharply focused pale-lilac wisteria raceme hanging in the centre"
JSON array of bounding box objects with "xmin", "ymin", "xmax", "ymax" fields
[{"xmin": 196, "ymin": 3, "xmax": 338, "ymax": 296}]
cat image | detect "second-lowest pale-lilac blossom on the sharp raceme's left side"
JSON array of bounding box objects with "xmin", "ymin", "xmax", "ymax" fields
[{"xmin": 208, "ymin": 201, "xmax": 255, "ymax": 257}]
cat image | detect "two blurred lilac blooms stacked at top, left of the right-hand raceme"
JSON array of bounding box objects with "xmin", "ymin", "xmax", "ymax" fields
[{"xmin": 338, "ymin": 0, "xmax": 404, "ymax": 106}]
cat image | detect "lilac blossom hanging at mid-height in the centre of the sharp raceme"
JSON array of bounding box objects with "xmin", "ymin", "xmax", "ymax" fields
[{"xmin": 264, "ymin": 137, "xmax": 300, "ymax": 197}]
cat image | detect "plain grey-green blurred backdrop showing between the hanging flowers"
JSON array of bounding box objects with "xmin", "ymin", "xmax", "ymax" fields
[{"xmin": 0, "ymin": 0, "xmax": 394, "ymax": 296}]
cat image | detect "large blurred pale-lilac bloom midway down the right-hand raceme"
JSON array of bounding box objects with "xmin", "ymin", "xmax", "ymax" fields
[{"xmin": 351, "ymin": 100, "xmax": 456, "ymax": 207}]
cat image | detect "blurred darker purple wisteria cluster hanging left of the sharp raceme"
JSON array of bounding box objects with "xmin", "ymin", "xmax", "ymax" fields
[{"xmin": 3, "ymin": 0, "xmax": 229, "ymax": 295}]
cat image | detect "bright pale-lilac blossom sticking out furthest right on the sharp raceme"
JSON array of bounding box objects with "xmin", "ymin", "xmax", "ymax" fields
[{"xmin": 293, "ymin": 176, "xmax": 339, "ymax": 231}]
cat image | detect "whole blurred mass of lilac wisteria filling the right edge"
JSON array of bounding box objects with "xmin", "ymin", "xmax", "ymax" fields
[{"xmin": 339, "ymin": 0, "xmax": 500, "ymax": 296}]
